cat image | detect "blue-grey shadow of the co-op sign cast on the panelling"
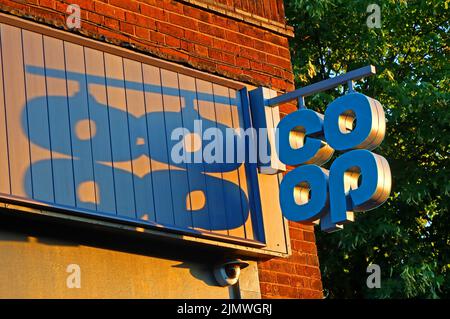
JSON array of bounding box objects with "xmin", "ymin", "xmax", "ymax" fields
[{"xmin": 22, "ymin": 65, "xmax": 250, "ymax": 238}]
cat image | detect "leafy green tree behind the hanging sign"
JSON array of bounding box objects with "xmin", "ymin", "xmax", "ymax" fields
[{"xmin": 285, "ymin": 0, "xmax": 450, "ymax": 298}]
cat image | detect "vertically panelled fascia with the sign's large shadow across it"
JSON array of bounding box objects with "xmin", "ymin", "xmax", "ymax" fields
[{"xmin": 0, "ymin": 24, "xmax": 258, "ymax": 240}]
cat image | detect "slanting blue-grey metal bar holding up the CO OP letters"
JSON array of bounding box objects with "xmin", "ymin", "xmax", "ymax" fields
[{"xmin": 265, "ymin": 65, "xmax": 377, "ymax": 106}]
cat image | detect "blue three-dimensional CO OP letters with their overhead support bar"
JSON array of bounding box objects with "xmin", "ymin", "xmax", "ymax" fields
[{"xmin": 250, "ymin": 66, "xmax": 391, "ymax": 232}]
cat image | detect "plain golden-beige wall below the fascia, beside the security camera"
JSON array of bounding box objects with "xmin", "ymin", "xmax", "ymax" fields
[{"xmin": 0, "ymin": 229, "xmax": 260, "ymax": 299}]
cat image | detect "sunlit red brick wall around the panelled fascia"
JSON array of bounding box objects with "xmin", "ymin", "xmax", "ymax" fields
[{"xmin": 0, "ymin": 0, "xmax": 322, "ymax": 298}]
